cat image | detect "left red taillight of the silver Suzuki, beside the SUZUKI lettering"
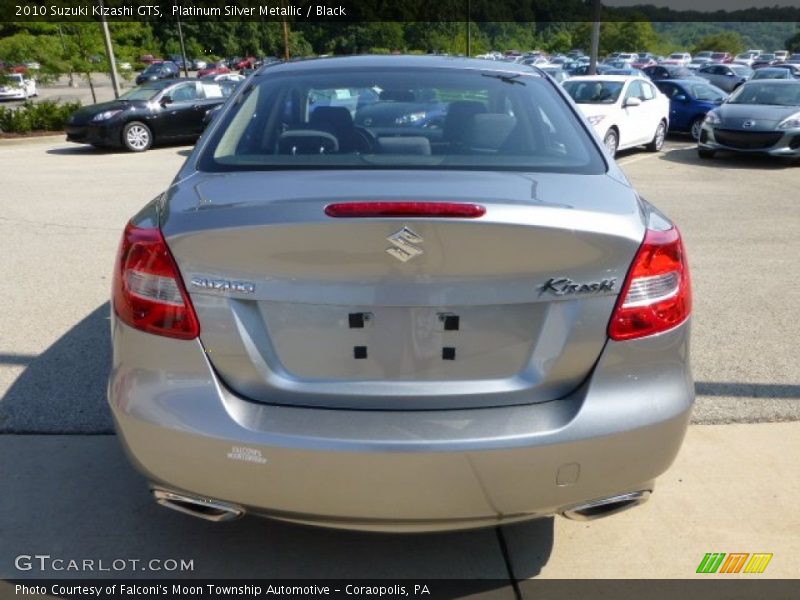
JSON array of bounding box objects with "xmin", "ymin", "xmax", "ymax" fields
[{"xmin": 112, "ymin": 223, "xmax": 200, "ymax": 340}]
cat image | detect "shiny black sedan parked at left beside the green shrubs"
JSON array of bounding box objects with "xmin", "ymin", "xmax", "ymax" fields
[{"xmin": 66, "ymin": 79, "xmax": 225, "ymax": 152}]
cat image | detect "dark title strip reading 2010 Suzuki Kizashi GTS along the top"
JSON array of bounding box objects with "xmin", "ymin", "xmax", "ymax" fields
[{"xmin": 0, "ymin": 0, "xmax": 800, "ymax": 23}]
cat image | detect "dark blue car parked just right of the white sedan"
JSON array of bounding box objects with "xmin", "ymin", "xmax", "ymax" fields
[{"xmin": 653, "ymin": 79, "xmax": 728, "ymax": 140}]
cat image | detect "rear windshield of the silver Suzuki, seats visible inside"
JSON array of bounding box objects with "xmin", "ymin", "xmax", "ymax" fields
[{"xmin": 198, "ymin": 68, "xmax": 606, "ymax": 173}]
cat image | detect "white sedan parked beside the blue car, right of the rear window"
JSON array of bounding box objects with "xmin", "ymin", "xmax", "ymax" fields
[{"xmin": 562, "ymin": 75, "xmax": 669, "ymax": 156}]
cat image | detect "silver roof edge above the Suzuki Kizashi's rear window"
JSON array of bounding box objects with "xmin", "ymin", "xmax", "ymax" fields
[{"xmin": 259, "ymin": 54, "xmax": 540, "ymax": 75}]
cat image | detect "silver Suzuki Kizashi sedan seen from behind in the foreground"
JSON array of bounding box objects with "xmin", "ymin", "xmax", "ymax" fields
[{"xmin": 108, "ymin": 56, "xmax": 694, "ymax": 531}]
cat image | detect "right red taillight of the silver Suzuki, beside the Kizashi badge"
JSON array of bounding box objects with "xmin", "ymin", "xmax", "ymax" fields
[{"xmin": 608, "ymin": 227, "xmax": 692, "ymax": 340}]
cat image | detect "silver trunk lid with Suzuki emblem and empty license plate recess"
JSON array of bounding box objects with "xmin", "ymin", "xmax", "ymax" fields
[{"xmin": 162, "ymin": 171, "xmax": 644, "ymax": 409}]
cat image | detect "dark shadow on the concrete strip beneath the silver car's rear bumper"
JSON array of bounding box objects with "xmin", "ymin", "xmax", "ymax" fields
[{"xmin": 0, "ymin": 435, "xmax": 553, "ymax": 584}]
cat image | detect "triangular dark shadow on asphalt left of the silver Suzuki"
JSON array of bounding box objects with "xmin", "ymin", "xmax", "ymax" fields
[{"xmin": 0, "ymin": 302, "xmax": 113, "ymax": 433}]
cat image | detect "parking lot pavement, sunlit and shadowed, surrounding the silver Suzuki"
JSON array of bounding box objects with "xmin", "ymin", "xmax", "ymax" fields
[{"xmin": 0, "ymin": 137, "xmax": 800, "ymax": 584}]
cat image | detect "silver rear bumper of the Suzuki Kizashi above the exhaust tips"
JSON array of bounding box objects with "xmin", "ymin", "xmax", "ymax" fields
[{"xmin": 109, "ymin": 317, "xmax": 694, "ymax": 531}]
